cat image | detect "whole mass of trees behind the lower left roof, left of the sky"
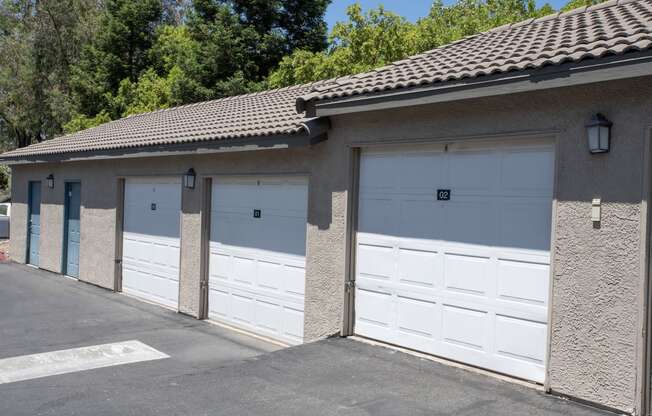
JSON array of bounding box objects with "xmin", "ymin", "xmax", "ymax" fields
[{"xmin": 0, "ymin": 0, "xmax": 330, "ymax": 148}]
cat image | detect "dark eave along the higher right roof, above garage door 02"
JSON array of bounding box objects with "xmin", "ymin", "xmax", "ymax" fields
[{"xmin": 304, "ymin": 50, "xmax": 652, "ymax": 117}]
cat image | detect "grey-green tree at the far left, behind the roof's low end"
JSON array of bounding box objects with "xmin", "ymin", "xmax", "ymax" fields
[{"xmin": 0, "ymin": 0, "xmax": 98, "ymax": 147}]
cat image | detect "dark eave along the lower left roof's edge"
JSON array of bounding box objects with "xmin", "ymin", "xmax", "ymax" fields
[{"xmin": 0, "ymin": 118, "xmax": 330, "ymax": 166}]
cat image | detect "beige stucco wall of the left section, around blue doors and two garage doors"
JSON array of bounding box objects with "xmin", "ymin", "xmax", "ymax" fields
[{"xmin": 11, "ymin": 144, "xmax": 346, "ymax": 340}]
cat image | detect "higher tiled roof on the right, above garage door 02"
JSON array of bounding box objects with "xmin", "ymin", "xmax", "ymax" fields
[{"xmin": 297, "ymin": 0, "xmax": 652, "ymax": 109}]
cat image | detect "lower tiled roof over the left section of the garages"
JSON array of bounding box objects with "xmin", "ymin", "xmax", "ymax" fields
[{"xmin": 0, "ymin": 84, "xmax": 326, "ymax": 160}]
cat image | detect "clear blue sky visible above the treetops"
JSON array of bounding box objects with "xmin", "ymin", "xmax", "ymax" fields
[{"xmin": 326, "ymin": 0, "xmax": 566, "ymax": 29}]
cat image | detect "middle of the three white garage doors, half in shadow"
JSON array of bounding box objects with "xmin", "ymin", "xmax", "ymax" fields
[{"xmin": 209, "ymin": 177, "xmax": 308, "ymax": 344}]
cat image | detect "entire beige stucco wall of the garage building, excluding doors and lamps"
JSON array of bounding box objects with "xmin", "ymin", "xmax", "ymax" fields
[{"xmin": 12, "ymin": 77, "xmax": 652, "ymax": 412}]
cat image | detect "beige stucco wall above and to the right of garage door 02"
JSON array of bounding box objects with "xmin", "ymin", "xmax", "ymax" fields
[{"xmin": 329, "ymin": 77, "xmax": 652, "ymax": 412}]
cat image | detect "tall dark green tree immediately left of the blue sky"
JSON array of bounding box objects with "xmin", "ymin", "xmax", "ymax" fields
[{"xmin": 188, "ymin": 0, "xmax": 330, "ymax": 97}]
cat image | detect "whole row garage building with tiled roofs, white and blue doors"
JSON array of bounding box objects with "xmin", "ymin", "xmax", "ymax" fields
[{"xmin": 0, "ymin": 0, "xmax": 652, "ymax": 414}]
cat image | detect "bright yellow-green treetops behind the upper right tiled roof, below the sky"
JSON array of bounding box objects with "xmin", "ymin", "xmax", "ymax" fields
[{"xmin": 268, "ymin": 0, "xmax": 554, "ymax": 87}]
